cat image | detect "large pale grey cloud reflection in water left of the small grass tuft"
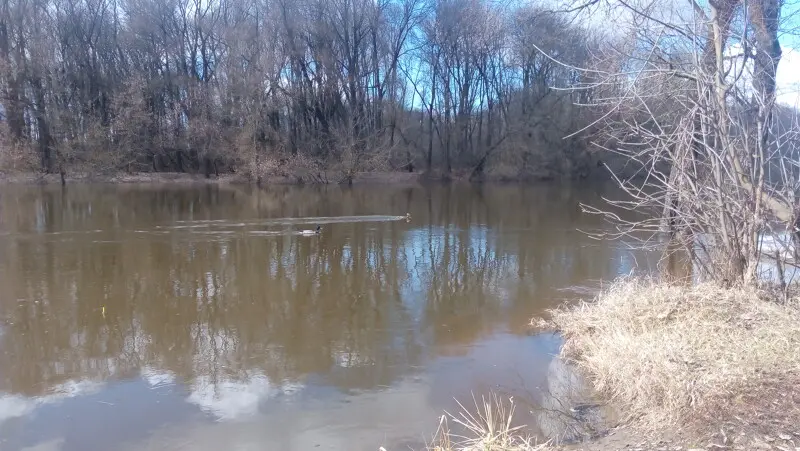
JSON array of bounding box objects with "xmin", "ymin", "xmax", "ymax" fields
[{"xmin": 114, "ymin": 372, "xmax": 438, "ymax": 451}]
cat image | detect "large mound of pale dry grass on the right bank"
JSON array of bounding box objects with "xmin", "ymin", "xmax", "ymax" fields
[{"xmin": 547, "ymin": 279, "xmax": 800, "ymax": 440}]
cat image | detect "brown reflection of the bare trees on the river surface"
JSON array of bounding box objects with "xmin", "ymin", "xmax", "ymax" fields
[{"xmin": 0, "ymin": 185, "xmax": 653, "ymax": 448}]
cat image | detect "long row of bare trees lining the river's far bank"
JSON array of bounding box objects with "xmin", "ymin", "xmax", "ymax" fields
[{"xmin": 0, "ymin": 0, "xmax": 596, "ymax": 181}]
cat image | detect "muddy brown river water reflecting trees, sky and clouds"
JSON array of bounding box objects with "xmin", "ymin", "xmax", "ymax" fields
[{"xmin": 0, "ymin": 185, "xmax": 655, "ymax": 451}]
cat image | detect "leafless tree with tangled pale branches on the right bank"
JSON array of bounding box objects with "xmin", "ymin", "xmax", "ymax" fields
[{"xmin": 564, "ymin": 0, "xmax": 798, "ymax": 283}]
